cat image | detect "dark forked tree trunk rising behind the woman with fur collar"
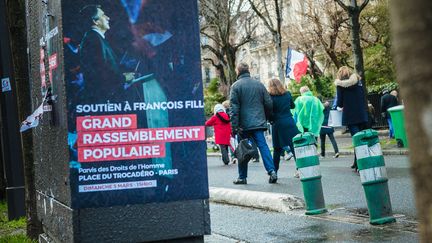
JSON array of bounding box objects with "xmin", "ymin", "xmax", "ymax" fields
[{"xmin": 334, "ymin": 0, "xmax": 369, "ymax": 82}]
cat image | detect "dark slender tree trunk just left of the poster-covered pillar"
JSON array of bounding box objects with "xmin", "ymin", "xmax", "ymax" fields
[{"xmin": 6, "ymin": 0, "xmax": 42, "ymax": 239}]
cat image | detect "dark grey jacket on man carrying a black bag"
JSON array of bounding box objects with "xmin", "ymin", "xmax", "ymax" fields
[{"xmin": 230, "ymin": 73, "xmax": 273, "ymax": 131}]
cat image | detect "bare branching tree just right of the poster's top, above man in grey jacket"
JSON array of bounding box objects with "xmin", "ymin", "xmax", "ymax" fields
[{"xmin": 199, "ymin": 0, "xmax": 254, "ymax": 96}]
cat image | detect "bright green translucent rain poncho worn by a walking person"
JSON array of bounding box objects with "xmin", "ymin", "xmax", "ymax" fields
[{"xmin": 294, "ymin": 91, "xmax": 324, "ymax": 136}]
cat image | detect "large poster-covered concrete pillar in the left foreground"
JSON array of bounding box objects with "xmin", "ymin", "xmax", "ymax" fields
[{"xmin": 27, "ymin": 0, "xmax": 210, "ymax": 242}]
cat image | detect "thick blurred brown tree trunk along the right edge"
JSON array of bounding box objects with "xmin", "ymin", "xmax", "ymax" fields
[{"xmin": 389, "ymin": 0, "xmax": 432, "ymax": 242}]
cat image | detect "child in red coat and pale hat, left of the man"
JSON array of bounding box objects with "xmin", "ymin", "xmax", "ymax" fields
[{"xmin": 205, "ymin": 104, "xmax": 231, "ymax": 165}]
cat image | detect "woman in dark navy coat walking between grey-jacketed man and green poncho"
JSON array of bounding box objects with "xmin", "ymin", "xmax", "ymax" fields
[{"xmin": 267, "ymin": 79, "xmax": 300, "ymax": 172}]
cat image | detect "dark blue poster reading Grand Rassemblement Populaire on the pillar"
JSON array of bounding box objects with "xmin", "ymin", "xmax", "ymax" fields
[{"xmin": 62, "ymin": 0, "xmax": 209, "ymax": 208}]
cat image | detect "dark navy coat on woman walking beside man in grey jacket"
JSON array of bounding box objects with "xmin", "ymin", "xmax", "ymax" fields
[{"xmin": 271, "ymin": 92, "xmax": 299, "ymax": 148}]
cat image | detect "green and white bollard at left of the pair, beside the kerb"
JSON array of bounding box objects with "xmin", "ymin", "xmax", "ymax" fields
[{"xmin": 293, "ymin": 132, "xmax": 327, "ymax": 215}]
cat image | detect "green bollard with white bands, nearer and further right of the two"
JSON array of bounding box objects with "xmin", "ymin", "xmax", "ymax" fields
[{"xmin": 353, "ymin": 129, "xmax": 396, "ymax": 225}]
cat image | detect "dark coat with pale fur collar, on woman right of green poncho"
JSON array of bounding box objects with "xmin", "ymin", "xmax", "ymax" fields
[{"xmin": 335, "ymin": 74, "xmax": 368, "ymax": 126}]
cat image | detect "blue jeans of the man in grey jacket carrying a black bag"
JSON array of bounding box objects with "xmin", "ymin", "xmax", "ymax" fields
[{"xmin": 238, "ymin": 130, "xmax": 275, "ymax": 179}]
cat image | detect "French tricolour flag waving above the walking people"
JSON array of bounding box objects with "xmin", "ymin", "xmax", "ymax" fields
[{"xmin": 285, "ymin": 48, "xmax": 309, "ymax": 83}]
